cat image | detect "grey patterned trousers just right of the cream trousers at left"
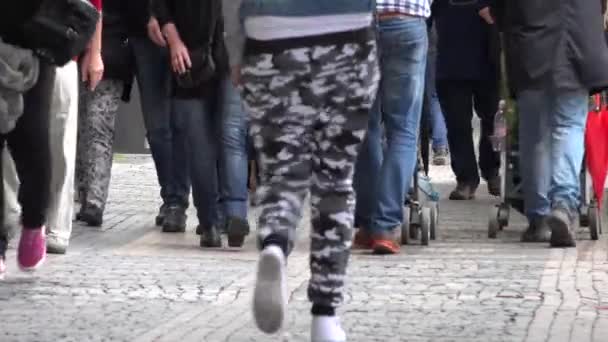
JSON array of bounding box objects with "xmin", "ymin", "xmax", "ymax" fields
[{"xmin": 76, "ymin": 80, "xmax": 123, "ymax": 212}]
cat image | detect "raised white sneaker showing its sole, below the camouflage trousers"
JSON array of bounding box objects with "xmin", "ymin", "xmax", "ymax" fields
[{"xmin": 253, "ymin": 246, "xmax": 287, "ymax": 334}]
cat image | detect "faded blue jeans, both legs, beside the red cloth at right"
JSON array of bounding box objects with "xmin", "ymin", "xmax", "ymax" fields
[{"xmin": 517, "ymin": 89, "xmax": 588, "ymax": 219}]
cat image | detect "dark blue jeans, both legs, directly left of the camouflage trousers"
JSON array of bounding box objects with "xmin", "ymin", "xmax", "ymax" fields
[{"xmin": 173, "ymin": 79, "xmax": 247, "ymax": 227}]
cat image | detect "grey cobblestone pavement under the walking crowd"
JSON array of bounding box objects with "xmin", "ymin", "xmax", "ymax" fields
[{"xmin": 0, "ymin": 157, "xmax": 608, "ymax": 342}]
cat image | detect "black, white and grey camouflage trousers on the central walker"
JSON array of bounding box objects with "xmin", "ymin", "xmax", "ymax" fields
[{"xmin": 242, "ymin": 41, "xmax": 379, "ymax": 307}]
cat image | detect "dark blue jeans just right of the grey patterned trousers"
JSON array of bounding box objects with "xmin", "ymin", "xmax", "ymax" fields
[{"xmin": 130, "ymin": 37, "xmax": 190, "ymax": 208}]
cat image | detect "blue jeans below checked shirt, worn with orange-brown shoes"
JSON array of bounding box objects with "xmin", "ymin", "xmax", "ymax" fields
[{"xmin": 355, "ymin": 17, "xmax": 428, "ymax": 233}]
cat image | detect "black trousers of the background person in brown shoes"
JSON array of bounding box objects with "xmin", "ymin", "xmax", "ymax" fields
[{"xmin": 437, "ymin": 80, "xmax": 500, "ymax": 186}]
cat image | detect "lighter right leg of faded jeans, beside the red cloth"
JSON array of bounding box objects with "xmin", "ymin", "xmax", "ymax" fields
[{"xmin": 549, "ymin": 90, "xmax": 589, "ymax": 213}]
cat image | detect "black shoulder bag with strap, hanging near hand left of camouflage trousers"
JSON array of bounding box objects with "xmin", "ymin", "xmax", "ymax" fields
[{"xmin": 175, "ymin": 7, "xmax": 218, "ymax": 89}]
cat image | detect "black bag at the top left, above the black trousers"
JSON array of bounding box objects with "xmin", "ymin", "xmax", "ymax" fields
[{"xmin": 23, "ymin": 0, "xmax": 99, "ymax": 66}]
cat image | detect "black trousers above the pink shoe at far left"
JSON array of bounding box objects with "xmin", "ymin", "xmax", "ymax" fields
[{"xmin": 0, "ymin": 62, "xmax": 55, "ymax": 255}]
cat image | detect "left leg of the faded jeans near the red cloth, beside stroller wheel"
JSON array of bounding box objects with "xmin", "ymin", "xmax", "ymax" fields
[{"xmin": 517, "ymin": 90, "xmax": 551, "ymax": 219}]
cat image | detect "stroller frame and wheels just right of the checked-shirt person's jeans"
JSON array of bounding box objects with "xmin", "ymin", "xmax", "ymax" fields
[{"xmin": 401, "ymin": 109, "xmax": 439, "ymax": 246}]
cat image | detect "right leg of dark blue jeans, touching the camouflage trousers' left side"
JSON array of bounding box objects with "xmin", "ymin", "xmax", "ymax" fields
[{"xmin": 217, "ymin": 79, "xmax": 248, "ymax": 219}]
